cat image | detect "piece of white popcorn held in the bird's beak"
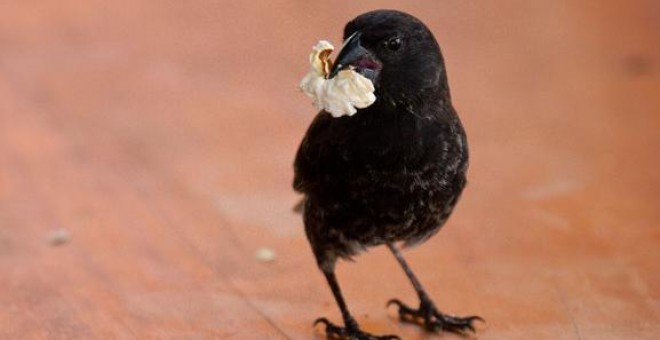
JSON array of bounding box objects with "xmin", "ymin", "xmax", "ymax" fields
[{"xmin": 300, "ymin": 40, "xmax": 376, "ymax": 117}]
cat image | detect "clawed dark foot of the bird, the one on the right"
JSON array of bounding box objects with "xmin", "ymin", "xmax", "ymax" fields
[{"xmin": 387, "ymin": 299, "xmax": 486, "ymax": 335}]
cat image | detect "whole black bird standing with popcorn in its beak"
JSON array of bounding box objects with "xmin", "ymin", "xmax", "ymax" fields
[{"xmin": 293, "ymin": 10, "xmax": 483, "ymax": 339}]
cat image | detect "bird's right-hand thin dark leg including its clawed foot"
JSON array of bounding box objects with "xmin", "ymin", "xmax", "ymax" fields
[{"xmin": 387, "ymin": 243, "xmax": 484, "ymax": 334}]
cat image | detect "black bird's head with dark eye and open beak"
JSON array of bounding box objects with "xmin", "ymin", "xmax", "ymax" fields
[{"xmin": 328, "ymin": 10, "xmax": 447, "ymax": 105}]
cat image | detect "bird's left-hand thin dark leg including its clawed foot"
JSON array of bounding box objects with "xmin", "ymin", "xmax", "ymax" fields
[{"xmin": 314, "ymin": 269, "xmax": 399, "ymax": 340}]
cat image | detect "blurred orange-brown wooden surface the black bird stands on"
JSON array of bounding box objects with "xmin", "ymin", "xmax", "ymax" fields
[{"xmin": 0, "ymin": 0, "xmax": 660, "ymax": 339}]
